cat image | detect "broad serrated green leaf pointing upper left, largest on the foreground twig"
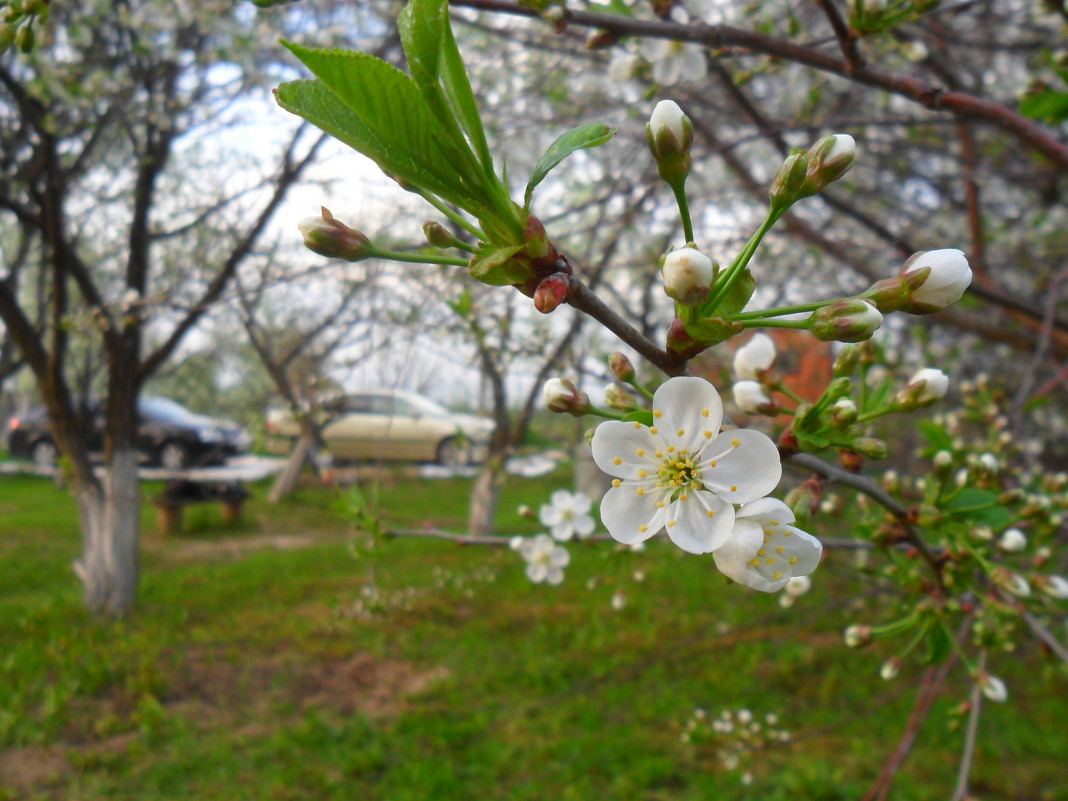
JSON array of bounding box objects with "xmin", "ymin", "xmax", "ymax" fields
[{"xmin": 277, "ymin": 44, "xmax": 486, "ymax": 217}]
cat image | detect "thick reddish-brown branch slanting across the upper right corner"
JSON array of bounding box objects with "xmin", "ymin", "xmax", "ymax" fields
[{"xmin": 453, "ymin": 0, "xmax": 1068, "ymax": 169}]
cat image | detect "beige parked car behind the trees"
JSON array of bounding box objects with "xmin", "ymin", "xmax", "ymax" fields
[{"xmin": 267, "ymin": 390, "xmax": 494, "ymax": 467}]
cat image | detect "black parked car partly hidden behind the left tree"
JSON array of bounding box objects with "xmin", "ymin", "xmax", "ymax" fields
[{"xmin": 7, "ymin": 395, "xmax": 251, "ymax": 470}]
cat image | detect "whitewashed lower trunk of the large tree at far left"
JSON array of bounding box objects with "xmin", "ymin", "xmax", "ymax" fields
[{"xmin": 74, "ymin": 449, "xmax": 141, "ymax": 617}]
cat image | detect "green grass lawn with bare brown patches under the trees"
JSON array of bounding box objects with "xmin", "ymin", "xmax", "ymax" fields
[{"xmin": 0, "ymin": 473, "xmax": 1068, "ymax": 801}]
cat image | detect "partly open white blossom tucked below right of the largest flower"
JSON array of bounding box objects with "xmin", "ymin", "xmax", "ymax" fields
[{"xmin": 712, "ymin": 498, "xmax": 823, "ymax": 593}]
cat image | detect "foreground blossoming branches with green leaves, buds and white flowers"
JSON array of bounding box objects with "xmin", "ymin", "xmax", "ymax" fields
[{"xmin": 267, "ymin": 0, "xmax": 1068, "ymax": 799}]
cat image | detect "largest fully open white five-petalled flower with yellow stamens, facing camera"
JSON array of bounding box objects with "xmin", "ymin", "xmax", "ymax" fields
[{"xmin": 592, "ymin": 376, "xmax": 792, "ymax": 555}]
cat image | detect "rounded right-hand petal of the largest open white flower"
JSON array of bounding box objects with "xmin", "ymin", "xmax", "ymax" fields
[{"xmin": 701, "ymin": 428, "xmax": 783, "ymax": 503}]
